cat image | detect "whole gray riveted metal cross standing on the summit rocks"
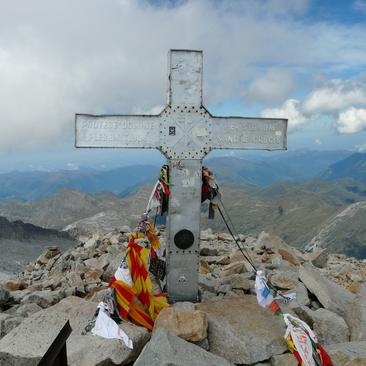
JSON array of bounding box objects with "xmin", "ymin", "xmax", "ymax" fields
[{"xmin": 75, "ymin": 50, "xmax": 287, "ymax": 302}]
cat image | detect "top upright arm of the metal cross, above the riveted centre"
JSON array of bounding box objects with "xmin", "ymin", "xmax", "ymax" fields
[{"xmin": 168, "ymin": 50, "xmax": 203, "ymax": 107}]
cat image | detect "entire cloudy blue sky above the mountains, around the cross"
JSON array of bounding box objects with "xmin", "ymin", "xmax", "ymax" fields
[{"xmin": 0, "ymin": 0, "xmax": 366, "ymax": 172}]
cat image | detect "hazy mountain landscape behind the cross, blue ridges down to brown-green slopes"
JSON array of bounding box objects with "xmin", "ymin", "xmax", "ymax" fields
[{"xmin": 0, "ymin": 147, "xmax": 366, "ymax": 270}]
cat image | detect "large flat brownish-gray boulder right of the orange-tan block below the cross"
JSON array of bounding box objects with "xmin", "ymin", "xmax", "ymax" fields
[{"xmin": 196, "ymin": 295, "xmax": 287, "ymax": 365}]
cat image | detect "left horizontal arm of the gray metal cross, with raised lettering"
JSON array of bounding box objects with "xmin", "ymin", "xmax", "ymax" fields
[{"xmin": 75, "ymin": 114, "xmax": 160, "ymax": 149}]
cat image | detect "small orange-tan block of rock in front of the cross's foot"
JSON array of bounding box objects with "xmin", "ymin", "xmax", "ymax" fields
[{"xmin": 154, "ymin": 307, "xmax": 208, "ymax": 342}]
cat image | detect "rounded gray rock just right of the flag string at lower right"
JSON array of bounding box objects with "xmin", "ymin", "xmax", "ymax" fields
[{"xmin": 311, "ymin": 309, "xmax": 350, "ymax": 344}]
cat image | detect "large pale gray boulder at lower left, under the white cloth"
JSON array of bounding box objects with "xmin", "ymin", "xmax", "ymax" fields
[{"xmin": 0, "ymin": 296, "xmax": 150, "ymax": 366}]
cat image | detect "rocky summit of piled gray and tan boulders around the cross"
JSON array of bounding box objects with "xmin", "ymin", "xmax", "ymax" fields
[{"xmin": 0, "ymin": 226, "xmax": 366, "ymax": 366}]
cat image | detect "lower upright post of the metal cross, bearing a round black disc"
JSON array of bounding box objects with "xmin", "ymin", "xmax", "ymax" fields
[{"xmin": 167, "ymin": 160, "xmax": 202, "ymax": 302}]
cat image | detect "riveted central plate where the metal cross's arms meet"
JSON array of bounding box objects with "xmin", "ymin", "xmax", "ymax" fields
[{"xmin": 160, "ymin": 106, "xmax": 212, "ymax": 159}]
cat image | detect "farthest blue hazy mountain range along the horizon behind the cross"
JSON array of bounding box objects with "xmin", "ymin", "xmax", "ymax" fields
[{"xmin": 0, "ymin": 151, "xmax": 350, "ymax": 200}]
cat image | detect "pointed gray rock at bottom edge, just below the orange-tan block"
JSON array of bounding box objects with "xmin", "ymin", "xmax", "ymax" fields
[{"xmin": 134, "ymin": 328, "xmax": 231, "ymax": 366}]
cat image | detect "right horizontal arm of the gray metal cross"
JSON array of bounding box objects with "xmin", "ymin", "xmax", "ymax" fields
[{"xmin": 211, "ymin": 117, "xmax": 287, "ymax": 150}]
